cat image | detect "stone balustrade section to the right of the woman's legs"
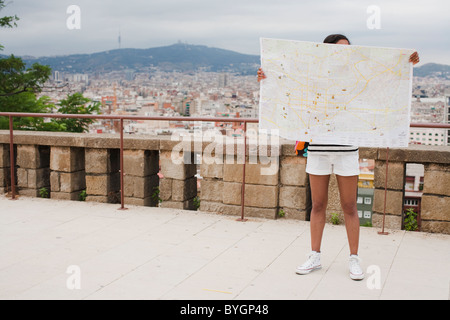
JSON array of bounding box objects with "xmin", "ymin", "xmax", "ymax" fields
[{"xmin": 372, "ymin": 145, "xmax": 450, "ymax": 234}]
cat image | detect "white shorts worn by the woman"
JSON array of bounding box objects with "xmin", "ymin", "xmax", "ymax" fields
[{"xmin": 306, "ymin": 152, "xmax": 359, "ymax": 177}]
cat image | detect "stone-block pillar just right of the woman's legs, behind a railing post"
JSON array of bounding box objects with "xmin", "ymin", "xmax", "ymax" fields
[{"xmin": 372, "ymin": 160, "xmax": 405, "ymax": 230}]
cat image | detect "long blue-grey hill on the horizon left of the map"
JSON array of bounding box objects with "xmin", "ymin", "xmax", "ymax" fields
[{"xmin": 16, "ymin": 44, "xmax": 260, "ymax": 73}]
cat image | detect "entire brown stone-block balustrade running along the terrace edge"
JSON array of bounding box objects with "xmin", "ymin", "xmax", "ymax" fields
[{"xmin": 0, "ymin": 131, "xmax": 450, "ymax": 234}]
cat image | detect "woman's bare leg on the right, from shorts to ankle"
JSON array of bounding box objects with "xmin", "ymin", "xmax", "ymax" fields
[{"xmin": 336, "ymin": 175, "xmax": 359, "ymax": 255}]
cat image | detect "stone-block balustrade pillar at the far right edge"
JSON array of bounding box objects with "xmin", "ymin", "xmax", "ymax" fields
[{"xmin": 421, "ymin": 163, "xmax": 450, "ymax": 234}]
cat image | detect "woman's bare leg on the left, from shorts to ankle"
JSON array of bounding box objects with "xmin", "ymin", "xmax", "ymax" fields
[{"xmin": 309, "ymin": 174, "xmax": 330, "ymax": 252}]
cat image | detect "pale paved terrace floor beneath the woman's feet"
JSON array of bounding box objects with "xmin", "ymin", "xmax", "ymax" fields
[{"xmin": 0, "ymin": 196, "xmax": 450, "ymax": 300}]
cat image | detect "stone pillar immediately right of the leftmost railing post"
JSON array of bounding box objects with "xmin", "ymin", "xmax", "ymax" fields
[{"xmin": 17, "ymin": 145, "xmax": 50, "ymax": 197}]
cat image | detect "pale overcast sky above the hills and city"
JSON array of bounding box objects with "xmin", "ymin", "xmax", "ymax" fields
[{"xmin": 0, "ymin": 0, "xmax": 450, "ymax": 65}]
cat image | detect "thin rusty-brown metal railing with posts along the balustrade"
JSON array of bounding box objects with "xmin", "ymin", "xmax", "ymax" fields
[{"xmin": 0, "ymin": 112, "xmax": 450, "ymax": 229}]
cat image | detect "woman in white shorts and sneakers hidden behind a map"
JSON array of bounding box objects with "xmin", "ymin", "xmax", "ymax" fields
[{"xmin": 258, "ymin": 34, "xmax": 419, "ymax": 280}]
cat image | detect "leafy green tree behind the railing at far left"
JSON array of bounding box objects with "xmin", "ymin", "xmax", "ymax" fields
[{"xmin": 0, "ymin": 0, "xmax": 100, "ymax": 132}]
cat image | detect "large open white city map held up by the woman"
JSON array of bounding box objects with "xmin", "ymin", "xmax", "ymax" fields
[{"xmin": 259, "ymin": 38, "xmax": 414, "ymax": 147}]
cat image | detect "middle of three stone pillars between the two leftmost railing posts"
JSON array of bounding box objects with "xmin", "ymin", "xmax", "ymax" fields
[{"xmin": 50, "ymin": 146, "xmax": 86, "ymax": 200}]
